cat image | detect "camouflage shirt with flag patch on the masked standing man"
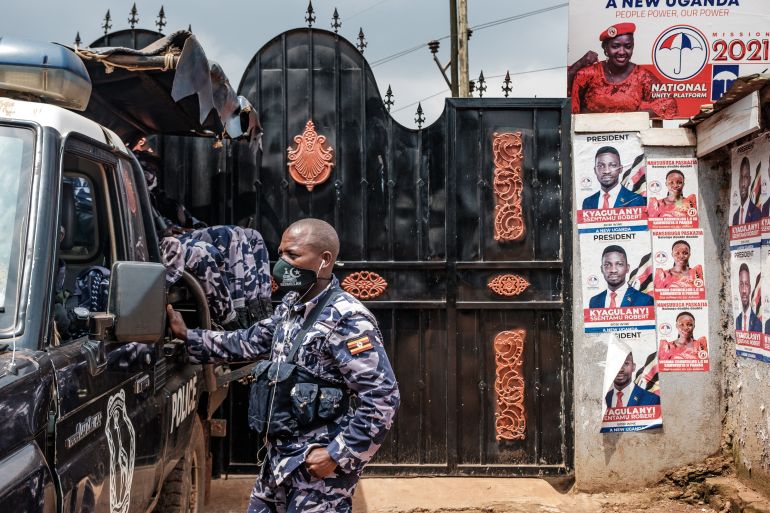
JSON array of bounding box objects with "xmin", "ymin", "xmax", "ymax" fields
[{"xmin": 187, "ymin": 278, "xmax": 400, "ymax": 484}]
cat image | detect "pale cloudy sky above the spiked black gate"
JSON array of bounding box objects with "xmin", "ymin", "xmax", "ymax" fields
[{"xmin": 0, "ymin": 0, "xmax": 568, "ymax": 127}]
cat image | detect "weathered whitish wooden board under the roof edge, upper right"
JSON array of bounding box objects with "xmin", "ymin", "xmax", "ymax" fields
[{"xmin": 695, "ymin": 91, "xmax": 762, "ymax": 157}]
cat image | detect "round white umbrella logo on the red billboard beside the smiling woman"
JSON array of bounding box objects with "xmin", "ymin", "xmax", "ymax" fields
[{"xmin": 652, "ymin": 25, "xmax": 709, "ymax": 80}]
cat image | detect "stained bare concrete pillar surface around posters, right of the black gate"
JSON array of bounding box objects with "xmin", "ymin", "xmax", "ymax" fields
[{"xmin": 572, "ymin": 121, "xmax": 728, "ymax": 491}]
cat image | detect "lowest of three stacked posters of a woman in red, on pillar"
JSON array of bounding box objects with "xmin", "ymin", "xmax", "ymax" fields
[{"xmin": 655, "ymin": 301, "xmax": 710, "ymax": 372}]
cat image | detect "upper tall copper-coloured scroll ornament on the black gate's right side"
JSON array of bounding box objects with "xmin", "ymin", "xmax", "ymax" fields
[{"xmin": 492, "ymin": 132, "xmax": 526, "ymax": 241}]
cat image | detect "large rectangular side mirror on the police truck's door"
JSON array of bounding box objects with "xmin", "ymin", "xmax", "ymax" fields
[{"xmin": 107, "ymin": 262, "xmax": 166, "ymax": 344}]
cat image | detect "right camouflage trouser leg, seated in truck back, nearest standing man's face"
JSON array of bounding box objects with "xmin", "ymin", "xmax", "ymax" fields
[{"xmin": 179, "ymin": 226, "xmax": 272, "ymax": 308}]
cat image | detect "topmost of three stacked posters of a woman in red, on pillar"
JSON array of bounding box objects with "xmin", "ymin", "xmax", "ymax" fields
[{"xmin": 647, "ymin": 158, "xmax": 698, "ymax": 229}]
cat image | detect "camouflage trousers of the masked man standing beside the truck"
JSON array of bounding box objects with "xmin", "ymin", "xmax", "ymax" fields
[{"xmin": 246, "ymin": 461, "xmax": 358, "ymax": 513}]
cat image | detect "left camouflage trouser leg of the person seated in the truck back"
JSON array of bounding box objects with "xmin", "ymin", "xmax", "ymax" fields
[{"xmin": 160, "ymin": 237, "xmax": 237, "ymax": 324}]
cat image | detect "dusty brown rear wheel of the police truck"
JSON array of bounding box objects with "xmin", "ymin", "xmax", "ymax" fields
[{"xmin": 158, "ymin": 415, "xmax": 206, "ymax": 513}]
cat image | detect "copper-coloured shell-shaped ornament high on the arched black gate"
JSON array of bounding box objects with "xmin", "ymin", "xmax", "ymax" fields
[{"xmin": 288, "ymin": 120, "xmax": 334, "ymax": 191}]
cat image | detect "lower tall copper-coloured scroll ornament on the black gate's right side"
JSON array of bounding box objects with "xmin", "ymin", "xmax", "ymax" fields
[{"xmin": 494, "ymin": 329, "xmax": 527, "ymax": 440}]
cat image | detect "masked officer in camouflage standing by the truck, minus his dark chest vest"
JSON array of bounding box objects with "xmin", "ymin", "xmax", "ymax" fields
[{"xmin": 168, "ymin": 219, "xmax": 400, "ymax": 513}]
